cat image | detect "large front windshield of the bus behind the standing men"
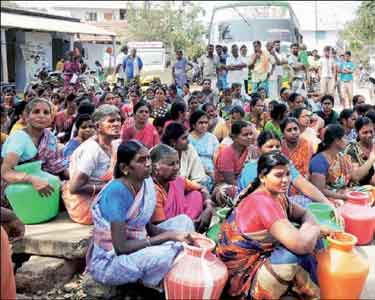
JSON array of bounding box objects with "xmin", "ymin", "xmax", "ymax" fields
[{"xmin": 210, "ymin": 4, "xmax": 294, "ymax": 44}]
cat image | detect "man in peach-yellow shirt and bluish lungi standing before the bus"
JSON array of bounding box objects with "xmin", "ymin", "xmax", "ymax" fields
[{"xmin": 249, "ymin": 41, "xmax": 269, "ymax": 96}]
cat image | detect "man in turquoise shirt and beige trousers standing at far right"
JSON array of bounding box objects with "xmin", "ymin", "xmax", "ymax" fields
[{"xmin": 340, "ymin": 51, "xmax": 355, "ymax": 109}]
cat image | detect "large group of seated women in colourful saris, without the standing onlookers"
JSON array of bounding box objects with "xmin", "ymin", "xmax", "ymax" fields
[{"xmin": 1, "ymin": 79, "xmax": 375, "ymax": 299}]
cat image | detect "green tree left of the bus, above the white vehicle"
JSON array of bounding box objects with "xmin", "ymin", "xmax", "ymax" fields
[{"xmin": 125, "ymin": 1, "xmax": 205, "ymax": 57}]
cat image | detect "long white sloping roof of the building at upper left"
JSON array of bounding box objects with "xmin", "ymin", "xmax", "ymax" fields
[{"xmin": 1, "ymin": 9, "xmax": 116, "ymax": 36}]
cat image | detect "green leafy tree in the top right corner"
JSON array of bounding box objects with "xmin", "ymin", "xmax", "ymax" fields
[{"xmin": 340, "ymin": 1, "xmax": 375, "ymax": 64}]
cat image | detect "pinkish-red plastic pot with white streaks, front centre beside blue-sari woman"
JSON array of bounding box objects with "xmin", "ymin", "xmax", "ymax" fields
[{"xmin": 164, "ymin": 234, "xmax": 228, "ymax": 300}]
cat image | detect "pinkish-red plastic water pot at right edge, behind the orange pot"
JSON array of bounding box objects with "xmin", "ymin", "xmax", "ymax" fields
[{"xmin": 341, "ymin": 203, "xmax": 375, "ymax": 245}]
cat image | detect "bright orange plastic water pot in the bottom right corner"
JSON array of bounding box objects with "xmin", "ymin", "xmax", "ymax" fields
[{"xmin": 317, "ymin": 232, "xmax": 369, "ymax": 300}]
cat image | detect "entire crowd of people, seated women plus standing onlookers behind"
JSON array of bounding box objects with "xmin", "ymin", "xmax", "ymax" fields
[{"xmin": 1, "ymin": 41, "xmax": 375, "ymax": 299}]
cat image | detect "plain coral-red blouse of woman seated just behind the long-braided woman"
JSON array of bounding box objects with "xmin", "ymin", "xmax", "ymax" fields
[{"xmin": 215, "ymin": 145, "xmax": 249, "ymax": 184}]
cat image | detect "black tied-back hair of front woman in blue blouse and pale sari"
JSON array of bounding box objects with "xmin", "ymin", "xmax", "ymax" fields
[{"xmin": 113, "ymin": 140, "xmax": 146, "ymax": 178}]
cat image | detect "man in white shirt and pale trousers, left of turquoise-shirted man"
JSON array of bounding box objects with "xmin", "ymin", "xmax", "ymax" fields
[{"xmin": 319, "ymin": 46, "xmax": 336, "ymax": 96}]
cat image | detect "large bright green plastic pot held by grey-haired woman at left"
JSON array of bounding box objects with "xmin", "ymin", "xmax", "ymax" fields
[{"xmin": 5, "ymin": 161, "xmax": 61, "ymax": 224}]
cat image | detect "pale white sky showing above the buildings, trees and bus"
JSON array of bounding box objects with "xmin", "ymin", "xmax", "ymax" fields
[{"xmin": 17, "ymin": 1, "xmax": 361, "ymax": 30}]
